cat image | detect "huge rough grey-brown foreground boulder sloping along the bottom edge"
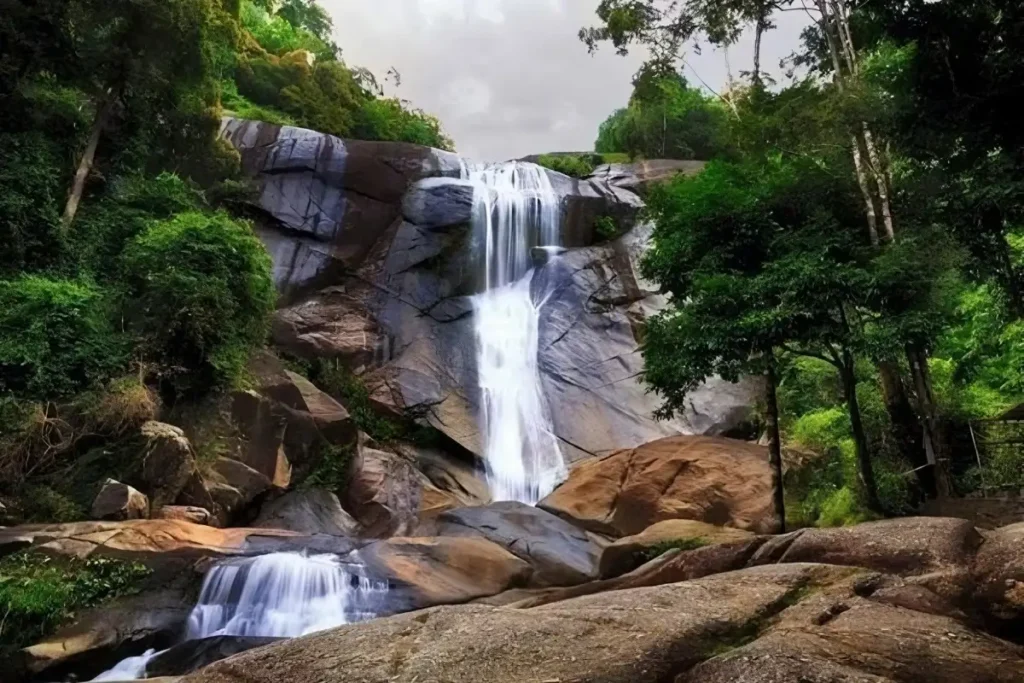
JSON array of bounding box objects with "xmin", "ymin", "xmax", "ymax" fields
[{"xmin": 184, "ymin": 565, "xmax": 849, "ymax": 683}]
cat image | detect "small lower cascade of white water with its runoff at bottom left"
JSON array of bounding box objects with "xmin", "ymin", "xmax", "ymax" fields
[{"xmin": 87, "ymin": 553, "xmax": 388, "ymax": 681}]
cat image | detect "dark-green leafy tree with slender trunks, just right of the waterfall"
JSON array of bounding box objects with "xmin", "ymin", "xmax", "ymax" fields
[{"xmin": 643, "ymin": 159, "xmax": 881, "ymax": 510}]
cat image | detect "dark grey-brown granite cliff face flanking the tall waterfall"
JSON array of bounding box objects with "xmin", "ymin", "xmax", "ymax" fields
[{"xmin": 223, "ymin": 119, "xmax": 758, "ymax": 460}]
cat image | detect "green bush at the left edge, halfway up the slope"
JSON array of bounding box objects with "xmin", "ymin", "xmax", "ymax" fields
[{"xmin": 0, "ymin": 275, "xmax": 125, "ymax": 400}]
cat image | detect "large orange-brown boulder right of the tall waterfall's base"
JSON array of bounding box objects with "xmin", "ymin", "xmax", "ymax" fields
[{"xmin": 540, "ymin": 436, "xmax": 777, "ymax": 537}]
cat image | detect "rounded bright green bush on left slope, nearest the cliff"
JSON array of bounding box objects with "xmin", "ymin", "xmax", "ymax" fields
[{"xmin": 122, "ymin": 211, "xmax": 274, "ymax": 395}]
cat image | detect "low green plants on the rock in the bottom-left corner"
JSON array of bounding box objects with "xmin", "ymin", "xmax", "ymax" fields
[{"xmin": 0, "ymin": 552, "xmax": 151, "ymax": 654}]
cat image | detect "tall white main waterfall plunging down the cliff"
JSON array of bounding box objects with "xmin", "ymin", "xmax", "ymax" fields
[{"xmin": 462, "ymin": 162, "xmax": 566, "ymax": 505}]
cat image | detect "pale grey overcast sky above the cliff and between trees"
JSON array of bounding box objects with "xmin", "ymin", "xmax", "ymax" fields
[{"xmin": 321, "ymin": 0, "xmax": 808, "ymax": 161}]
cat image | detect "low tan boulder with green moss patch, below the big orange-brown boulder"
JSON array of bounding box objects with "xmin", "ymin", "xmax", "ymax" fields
[{"xmin": 600, "ymin": 519, "xmax": 754, "ymax": 579}]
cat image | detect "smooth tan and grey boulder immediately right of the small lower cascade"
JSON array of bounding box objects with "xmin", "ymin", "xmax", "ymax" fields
[{"xmin": 348, "ymin": 538, "xmax": 532, "ymax": 612}]
